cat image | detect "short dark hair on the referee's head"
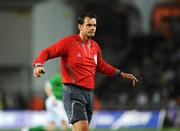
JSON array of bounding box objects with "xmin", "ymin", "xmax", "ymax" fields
[{"xmin": 77, "ymin": 12, "xmax": 96, "ymax": 25}]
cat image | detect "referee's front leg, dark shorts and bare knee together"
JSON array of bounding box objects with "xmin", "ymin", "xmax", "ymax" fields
[{"xmin": 63, "ymin": 85, "xmax": 91, "ymax": 131}]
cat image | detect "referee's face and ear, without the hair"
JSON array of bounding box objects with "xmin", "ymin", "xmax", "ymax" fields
[{"xmin": 79, "ymin": 17, "xmax": 96, "ymax": 38}]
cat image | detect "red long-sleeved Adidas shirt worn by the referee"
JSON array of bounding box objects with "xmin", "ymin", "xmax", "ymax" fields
[{"xmin": 33, "ymin": 35, "xmax": 117, "ymax": 89}]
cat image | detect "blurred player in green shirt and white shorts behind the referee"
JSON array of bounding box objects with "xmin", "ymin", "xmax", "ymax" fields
[{"xmin": 22, "ymin": 74, "xmax": 68, "ymax": 131}]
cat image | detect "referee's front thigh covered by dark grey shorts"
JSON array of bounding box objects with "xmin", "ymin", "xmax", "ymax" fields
[{"xmin": 63, "ymin": 85, "xmax": 88, "ymax": 124}]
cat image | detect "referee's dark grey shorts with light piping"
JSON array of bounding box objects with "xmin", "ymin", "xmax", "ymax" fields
[{"xmin": 62, "ymin": 84, "xmax": 94, "ymax": 124}]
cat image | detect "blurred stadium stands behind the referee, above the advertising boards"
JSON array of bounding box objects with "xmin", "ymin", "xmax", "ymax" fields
[{"xmin": 0, "ymin": 0, "xmax": 180, "ymax": 127}]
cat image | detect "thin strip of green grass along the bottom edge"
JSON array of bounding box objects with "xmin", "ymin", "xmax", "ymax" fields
[{"xmin": 0, "ymin": 128, "xmax": 180, "ymax": 131}]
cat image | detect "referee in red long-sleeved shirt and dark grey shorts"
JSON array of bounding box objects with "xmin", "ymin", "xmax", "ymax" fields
[{"xmin": 33, "ymin": 12, "xmax": 138, "ymax": 131}]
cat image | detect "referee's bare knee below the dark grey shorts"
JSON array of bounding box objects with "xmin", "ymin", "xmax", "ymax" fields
[{"xmin": 73, "ymin": 120, "xmax": 89, "ymax": 131}]
